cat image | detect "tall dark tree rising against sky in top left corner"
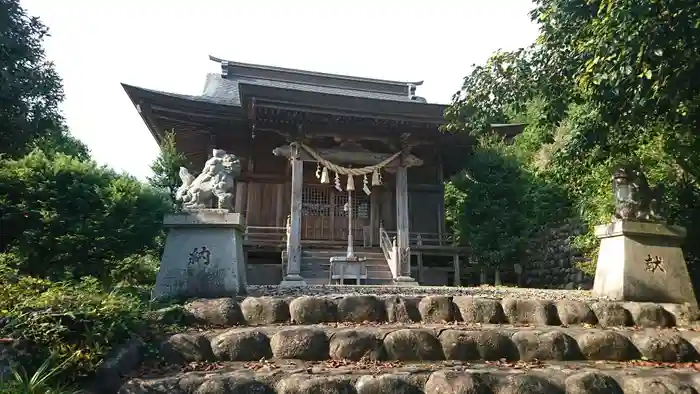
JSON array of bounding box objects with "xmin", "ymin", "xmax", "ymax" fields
[{"xmin": 0, "ymin": 0, "xmax": 64, "ymax": 157}]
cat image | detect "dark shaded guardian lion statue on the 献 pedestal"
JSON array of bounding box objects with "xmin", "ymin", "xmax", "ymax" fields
[{"xmin": 612, "ymin": 165, "xmax": 664, "ymax": 222}]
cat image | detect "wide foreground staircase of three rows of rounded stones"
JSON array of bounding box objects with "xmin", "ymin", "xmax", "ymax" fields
[{"xmin": 115, "ymin": 286, "xmax": 700, "ymax": 394}]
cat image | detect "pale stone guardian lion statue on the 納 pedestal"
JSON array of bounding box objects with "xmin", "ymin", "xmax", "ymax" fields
[{"xmin": 175, "ymin": 149, "xmax": 241, "ymax": 210}]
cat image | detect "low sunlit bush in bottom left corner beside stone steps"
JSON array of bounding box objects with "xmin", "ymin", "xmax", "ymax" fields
[{"xmin": 0, "ymin": 270, "xmax": 148, "ymax": 381}]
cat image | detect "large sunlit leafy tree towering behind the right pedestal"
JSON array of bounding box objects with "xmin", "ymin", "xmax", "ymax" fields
[{"xmin": 446, "ymin": 0, "xmax": 700, "ymax": 278}]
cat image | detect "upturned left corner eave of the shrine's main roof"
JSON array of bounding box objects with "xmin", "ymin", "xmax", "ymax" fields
[{"xmin": 121, "ymin": 83, "xmax": 244, "ymax": 143}]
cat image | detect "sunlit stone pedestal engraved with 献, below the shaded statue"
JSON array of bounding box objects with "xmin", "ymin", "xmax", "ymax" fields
[{"xmin": 593, "ymin": 221, "xmax": 697, "ymax": 308}]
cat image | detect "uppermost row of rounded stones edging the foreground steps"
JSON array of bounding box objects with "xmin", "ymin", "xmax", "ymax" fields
[{"xmin": 179, "ymin": 294, "xmax": 696, "ymax": 327}]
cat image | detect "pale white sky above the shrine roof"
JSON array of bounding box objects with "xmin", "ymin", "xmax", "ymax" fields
[{"xmin": 21, "ymin": 0, "xmax": 537, "ymax": 179}]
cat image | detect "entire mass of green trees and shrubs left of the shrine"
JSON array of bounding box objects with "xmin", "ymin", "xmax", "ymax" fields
[{"xmin": 0, "ymin": 0, "xmax": 183, "ymax": 393}]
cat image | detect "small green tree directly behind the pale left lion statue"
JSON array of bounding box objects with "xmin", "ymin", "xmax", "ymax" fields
[{"xmin": 148, "ymin": 131, "xmax": 189, "ymax": 205}]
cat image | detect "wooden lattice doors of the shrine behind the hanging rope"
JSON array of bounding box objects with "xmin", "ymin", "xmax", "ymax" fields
[{"xmin": 301, "ymin": 184, "xmax": 370, "ymax": 244}]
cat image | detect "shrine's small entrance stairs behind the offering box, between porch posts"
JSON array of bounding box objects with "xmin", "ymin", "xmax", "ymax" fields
[{"xmin": 301, "ymin": 248, "xmax": 393, "ymax": 285}]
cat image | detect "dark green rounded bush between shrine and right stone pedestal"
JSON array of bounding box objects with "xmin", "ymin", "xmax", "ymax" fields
[{"xmin": 445, "ymin": 132, "xmax": 570, "ymax": 267}]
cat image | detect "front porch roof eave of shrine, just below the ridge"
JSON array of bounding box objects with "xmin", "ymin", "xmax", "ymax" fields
[{"xmin": 239, "ymin": 82, "xmax": 446, "ymax": 125}]
